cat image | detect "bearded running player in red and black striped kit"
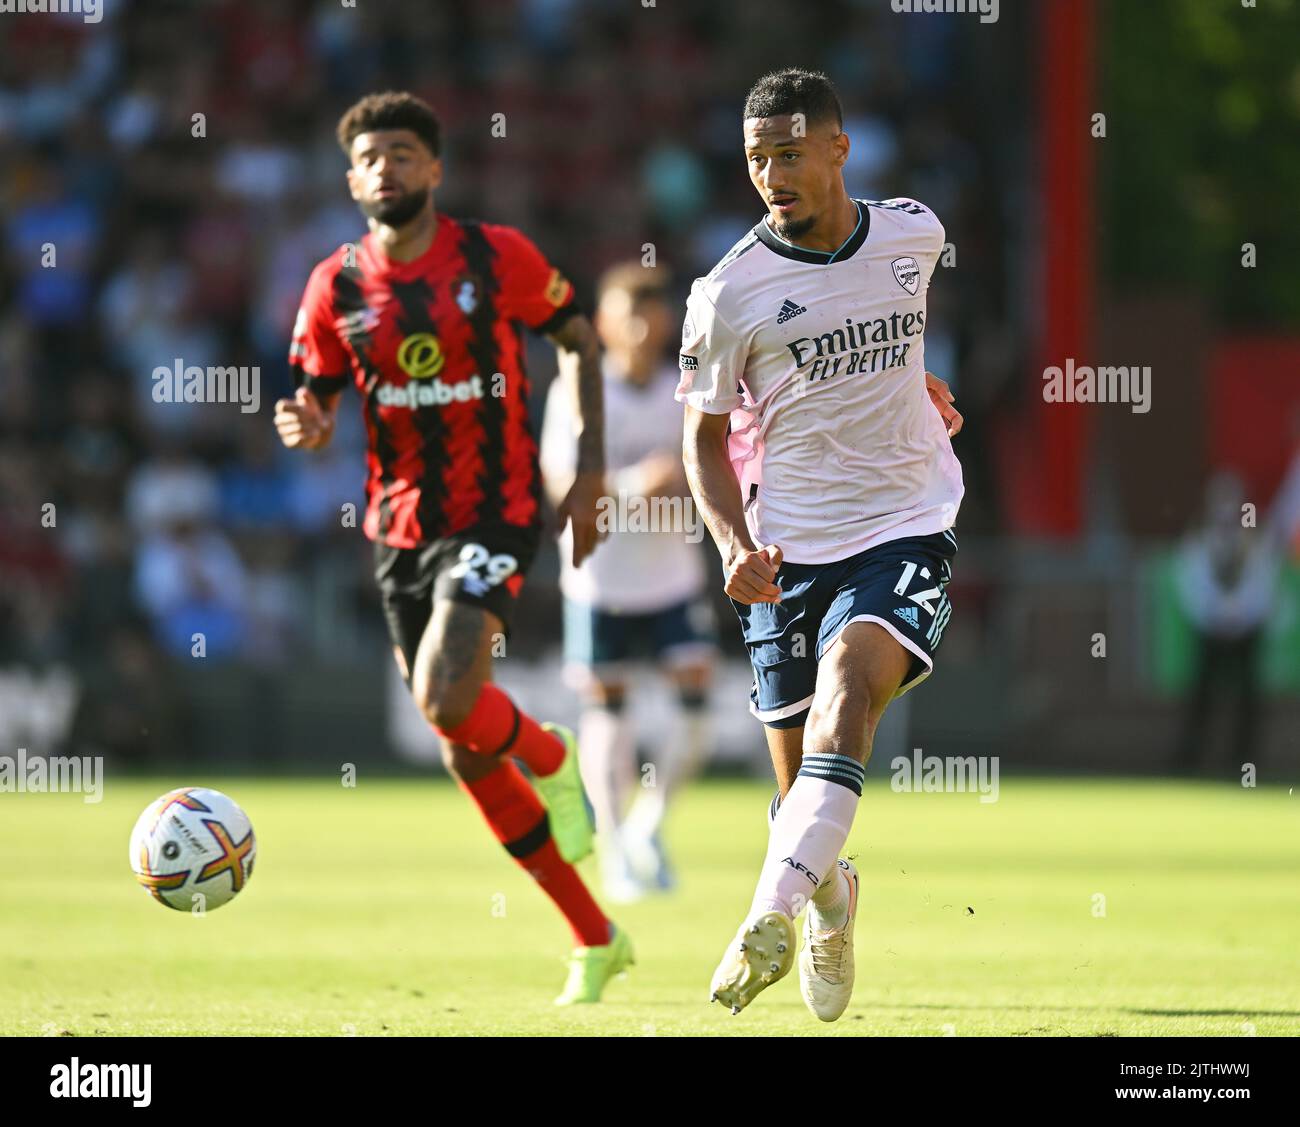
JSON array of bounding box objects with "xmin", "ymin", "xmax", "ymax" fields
[{"xmin": 276, "ymin": 92, "xmax": 632, "ymax": 1004}]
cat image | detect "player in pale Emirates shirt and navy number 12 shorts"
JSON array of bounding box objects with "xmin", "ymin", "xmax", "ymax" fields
[{"xmin": 676, "ymin": 69, "xmax": 962, "ymax": 1022}]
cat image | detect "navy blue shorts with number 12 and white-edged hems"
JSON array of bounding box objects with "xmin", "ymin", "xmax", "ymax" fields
[{"xmin": 731, "ymin": 529, "xmax": 957, "ymax": 728}]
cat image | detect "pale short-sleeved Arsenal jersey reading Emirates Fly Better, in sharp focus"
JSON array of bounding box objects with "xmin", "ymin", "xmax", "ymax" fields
[{"xmin": 676, "ymin": 199, "xmax": 963, "ymax": 563}]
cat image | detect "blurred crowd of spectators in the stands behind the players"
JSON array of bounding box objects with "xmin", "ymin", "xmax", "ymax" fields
[{"xmin": 0, "ymin": 0, "xmax": 1006, "ymax": 759}]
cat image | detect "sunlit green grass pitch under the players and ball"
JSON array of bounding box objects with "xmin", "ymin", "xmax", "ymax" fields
[{"xmin": 0, "ymin": 777, "xmax": 1300, "ymax": 1036}]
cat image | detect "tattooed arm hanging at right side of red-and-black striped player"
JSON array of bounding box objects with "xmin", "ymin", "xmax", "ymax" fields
[{"xmin": 547, "ymin": 315, "xmax": 605, "ymax": 567}]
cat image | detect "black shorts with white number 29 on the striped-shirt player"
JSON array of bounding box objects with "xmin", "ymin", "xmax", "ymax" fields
[{"xmin": 374, "ymin": 521, "xmax": 542, "ymax": 671}]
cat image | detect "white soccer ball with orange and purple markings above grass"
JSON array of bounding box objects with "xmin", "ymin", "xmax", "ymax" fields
[{"xmin": 131, "ymin": 786, "xmax": 257, "ymax": 913}]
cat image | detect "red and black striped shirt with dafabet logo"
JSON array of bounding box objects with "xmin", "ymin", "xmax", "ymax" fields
[{"xmin": 297, "ymin": 214, "xmax": 577, "ymax": 547}]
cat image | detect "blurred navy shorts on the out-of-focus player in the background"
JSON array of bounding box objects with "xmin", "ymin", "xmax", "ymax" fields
[{"xmin": 564, "ymin": 599, "xmax": 714, "ymax": 682}]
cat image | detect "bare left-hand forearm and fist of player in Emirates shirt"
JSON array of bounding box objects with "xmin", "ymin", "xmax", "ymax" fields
[{"xmin": 681, "ymin": 406, "xmax": 781, "ymax": 604}]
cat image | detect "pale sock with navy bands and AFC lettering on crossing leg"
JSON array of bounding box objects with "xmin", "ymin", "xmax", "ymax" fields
[{"xmin": 750, "ymin": 754, "xmax": 866, "ymax": 919}]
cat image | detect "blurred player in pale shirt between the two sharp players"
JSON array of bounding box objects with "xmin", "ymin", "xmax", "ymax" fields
[{"xmin": 541, "ymin": 261, "xmax": 715, "ymax": 902}]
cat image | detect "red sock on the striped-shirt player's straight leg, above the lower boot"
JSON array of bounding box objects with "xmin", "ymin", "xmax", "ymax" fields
[{"xmin": 460, "ymin": 759, "xmax": 610, "ymax": 948}]
